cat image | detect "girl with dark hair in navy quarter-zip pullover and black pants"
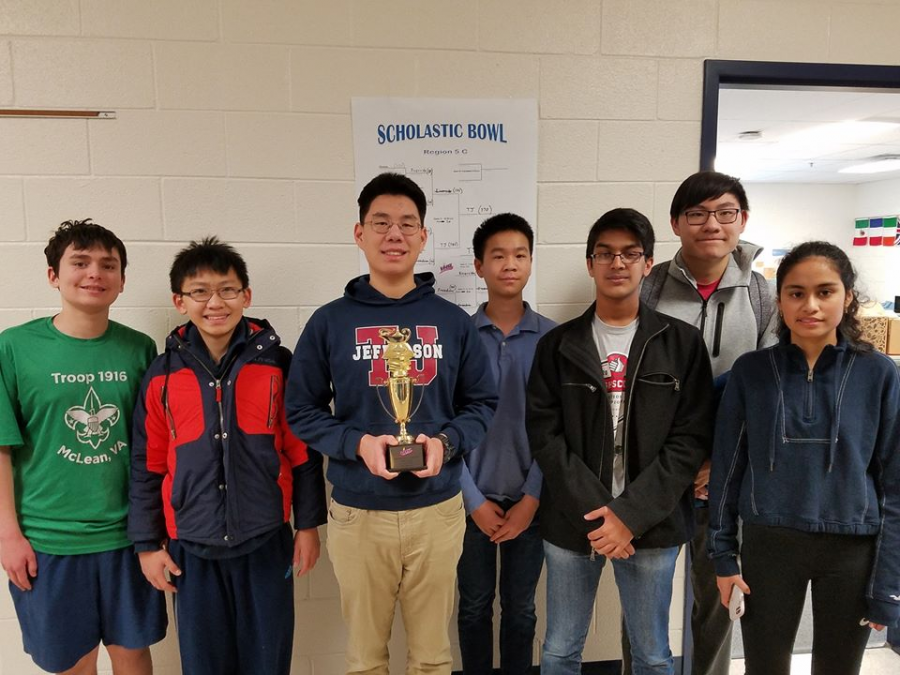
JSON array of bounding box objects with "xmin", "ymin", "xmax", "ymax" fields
[{"xmin": 709, "ymin": 242, "xmax": 900, "ymax": 675}]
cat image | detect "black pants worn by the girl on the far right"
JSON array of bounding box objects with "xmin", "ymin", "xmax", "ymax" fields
[{"xmin": 741, "ymin": 523, "xmax": 875, "ymax": 675}]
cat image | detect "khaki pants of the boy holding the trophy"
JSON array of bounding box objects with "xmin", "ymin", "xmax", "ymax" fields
[{"xmin": 328, "ymin": 495, "xmax": 466, "ymax": 675}]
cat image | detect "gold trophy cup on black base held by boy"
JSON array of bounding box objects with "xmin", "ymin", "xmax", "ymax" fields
[{"xmin": 378, "ymin": 328, "xmax": 426, "ymax": 473}]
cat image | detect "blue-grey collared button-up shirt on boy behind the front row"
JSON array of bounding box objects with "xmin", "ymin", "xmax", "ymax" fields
[{"xmin": 460, "ymin": 302, "xmax": 556, "ymax": 513}]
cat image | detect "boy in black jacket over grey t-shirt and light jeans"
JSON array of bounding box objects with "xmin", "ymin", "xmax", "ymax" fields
[{"xmin": 527, "ymin": 209, "xmax": 713, "ymax": 675}]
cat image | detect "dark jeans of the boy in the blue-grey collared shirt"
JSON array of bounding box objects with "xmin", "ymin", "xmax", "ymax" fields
[{"xmin": 457, "ymin": 518, "xmax": 544, "ymax": 675}]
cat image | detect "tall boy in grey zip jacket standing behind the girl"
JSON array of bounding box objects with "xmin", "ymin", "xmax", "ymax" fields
[{"xmin": 622, "ymin": 171, "xmax": 778, "ymax": 675}]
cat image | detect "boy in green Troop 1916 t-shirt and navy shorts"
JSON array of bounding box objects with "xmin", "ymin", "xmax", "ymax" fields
[{"xmin": 0, "ymin": 220, "xmax": 166, "ymax": 675}]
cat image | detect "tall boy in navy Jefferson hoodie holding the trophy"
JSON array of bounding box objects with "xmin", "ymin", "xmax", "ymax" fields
[{"xmin": 286, "ymin": 173, "xmax": 497, "ymax": 674}]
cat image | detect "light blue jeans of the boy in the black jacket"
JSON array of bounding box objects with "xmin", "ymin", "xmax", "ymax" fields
[{"xmin": 541, "ymin": 541, "xmax": 679, "ymax": 675}]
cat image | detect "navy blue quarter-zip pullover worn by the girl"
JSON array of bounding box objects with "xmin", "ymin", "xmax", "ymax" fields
[{"xmin": 709, "ymin": 335, "xmax": 900, "ymax": 625}]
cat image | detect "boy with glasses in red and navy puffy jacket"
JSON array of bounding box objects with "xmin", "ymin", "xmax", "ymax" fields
[{"xmin": 128, "ymin": 237, "xmax": 326, "ymax": 675}]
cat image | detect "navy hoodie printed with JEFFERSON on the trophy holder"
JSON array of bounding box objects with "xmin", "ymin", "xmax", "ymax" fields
[{"xmin": 285, "ymin": 273, "xmax": 497, "ymax": 511}]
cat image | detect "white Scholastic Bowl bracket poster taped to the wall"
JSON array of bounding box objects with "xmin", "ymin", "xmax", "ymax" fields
[{"xmin": 353, "ymin": 98, "xmax": 538, "ymax": 312}]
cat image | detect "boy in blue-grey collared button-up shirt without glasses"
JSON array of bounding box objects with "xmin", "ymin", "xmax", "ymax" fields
[{"xmin": 458, "ymin": 213, "xmax": 556, "ymax": 675}]
